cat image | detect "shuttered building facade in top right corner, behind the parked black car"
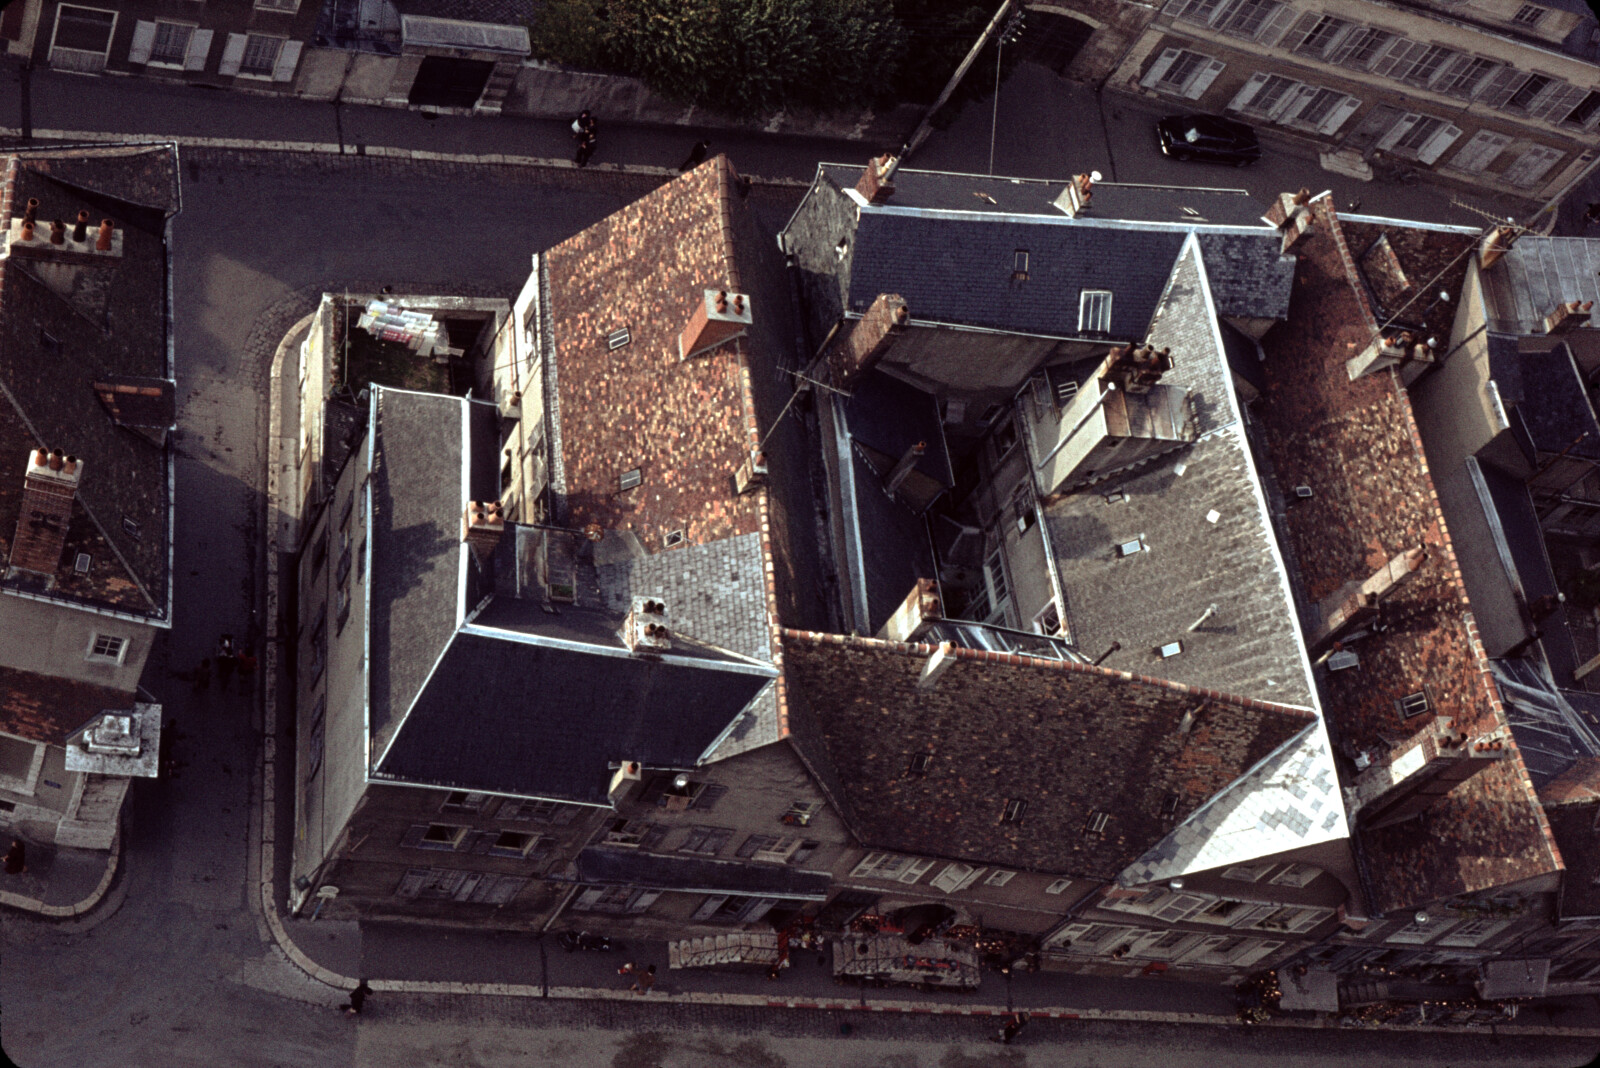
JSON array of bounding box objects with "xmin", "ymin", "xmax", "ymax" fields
[{"xmin": 1112, "ymin": 0, "xmax": 1600, "ymax": 197}]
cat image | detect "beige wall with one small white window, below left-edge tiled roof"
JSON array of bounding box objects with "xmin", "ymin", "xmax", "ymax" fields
[{"xmin": 0, "ymin": 595, "xmax": 157, "ymax": 694}]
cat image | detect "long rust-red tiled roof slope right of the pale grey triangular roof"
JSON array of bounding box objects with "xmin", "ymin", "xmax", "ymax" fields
[{"xmin": 1259, "ymin": 197, "xmax": 1560, "ymax": 911}]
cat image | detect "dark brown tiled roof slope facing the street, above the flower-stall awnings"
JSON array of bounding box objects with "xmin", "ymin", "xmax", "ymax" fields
[{"xmin": 782, "ymin": 630, "xmax": 1315, "ymax": 879}]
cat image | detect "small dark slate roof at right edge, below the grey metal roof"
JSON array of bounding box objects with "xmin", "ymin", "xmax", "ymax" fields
[{"xmin": 1488, "ymin": 334, "xmax": 1600, "ymax": 464}]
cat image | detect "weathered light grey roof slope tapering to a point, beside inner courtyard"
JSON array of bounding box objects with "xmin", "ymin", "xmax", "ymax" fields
[{"xmin": 1045, "ymin": 246, "xmax": 1314, "ymax": 707}]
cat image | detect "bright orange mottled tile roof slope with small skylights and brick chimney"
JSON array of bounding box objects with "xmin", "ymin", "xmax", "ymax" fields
[{"xmin": 546, "ymin": 157, "xmax": 768, "ymax": 552}]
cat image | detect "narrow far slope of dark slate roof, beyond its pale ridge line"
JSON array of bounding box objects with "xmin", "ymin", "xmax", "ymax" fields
[{"xmin": 818, "ymin": 163, "xmax": 1262, "ymax": 225}]
